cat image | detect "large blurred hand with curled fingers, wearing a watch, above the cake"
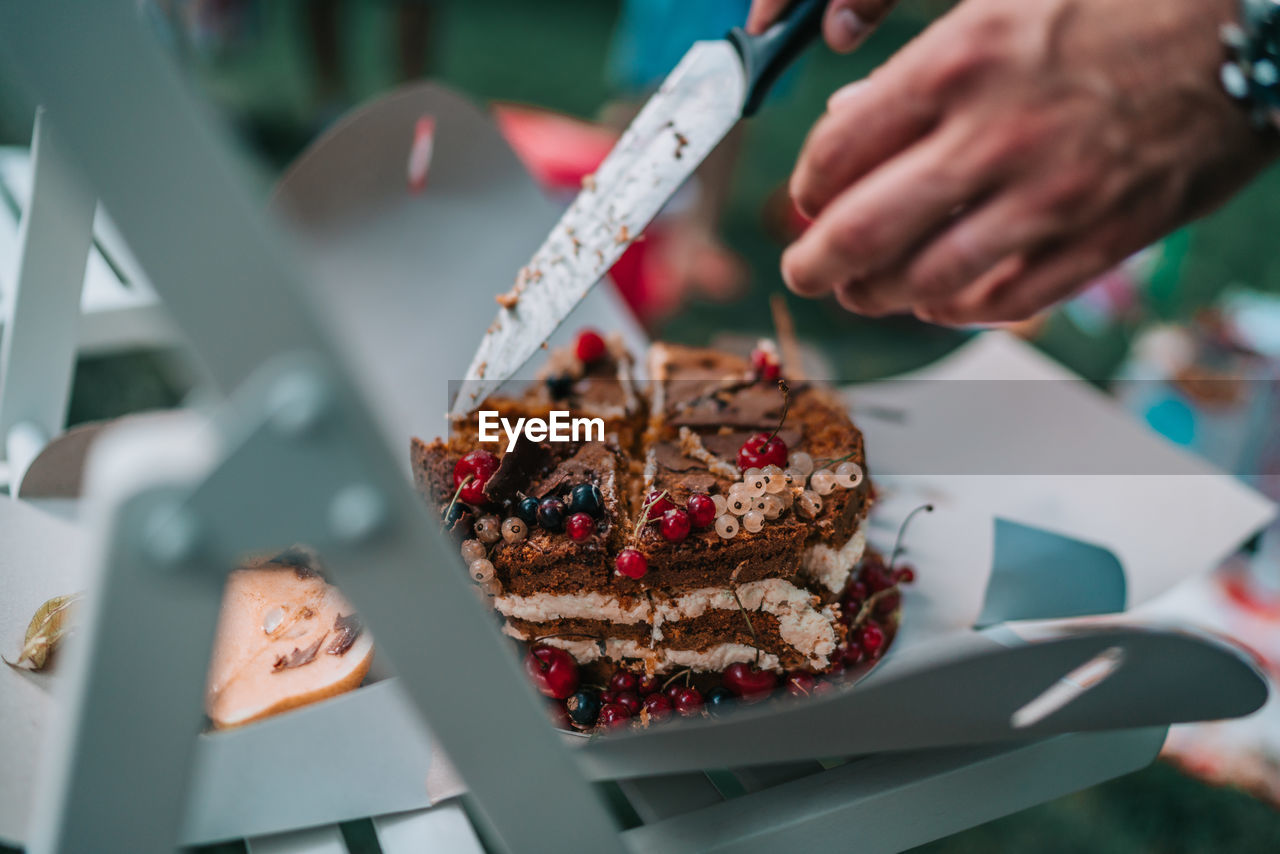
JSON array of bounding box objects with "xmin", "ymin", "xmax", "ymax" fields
[{"xmin": 782, "ymin": 0, "xmax": 1276, "ymax": 323}]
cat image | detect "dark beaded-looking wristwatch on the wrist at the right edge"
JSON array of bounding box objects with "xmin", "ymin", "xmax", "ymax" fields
[{"xmin": 1220, "ymin": 0, "xmax": 1280, "ymax": 129}]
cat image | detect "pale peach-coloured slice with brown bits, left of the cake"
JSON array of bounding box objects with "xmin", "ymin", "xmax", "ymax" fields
[{"xmin": 205, "ymin": 562, "xmax": 374, "ymax": 729}]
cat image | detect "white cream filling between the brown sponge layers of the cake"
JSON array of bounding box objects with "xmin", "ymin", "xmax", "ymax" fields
[{"xmin": 494, "ymin": 579, "xmax": 837, "ymax": 670}]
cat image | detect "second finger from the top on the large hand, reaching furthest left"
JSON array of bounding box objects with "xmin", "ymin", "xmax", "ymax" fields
[{"xmin": 782, "ymin": 122, "xmax": 989, "ymax": 306}]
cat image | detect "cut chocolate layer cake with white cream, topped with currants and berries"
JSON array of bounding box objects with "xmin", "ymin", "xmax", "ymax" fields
[{"xmin": 412, "ymin": 338, "xmax": 869, "ymax": 675}]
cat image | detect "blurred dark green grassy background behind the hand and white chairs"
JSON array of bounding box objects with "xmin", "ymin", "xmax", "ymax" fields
[{"xmin": 0, "ymin": 0, "xmax": 1280, "ymax": 854}]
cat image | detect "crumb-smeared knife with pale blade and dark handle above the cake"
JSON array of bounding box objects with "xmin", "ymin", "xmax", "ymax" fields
[{"xmin": 451, "ymin": 0, "xmax": 827, "ymax": 417}]
